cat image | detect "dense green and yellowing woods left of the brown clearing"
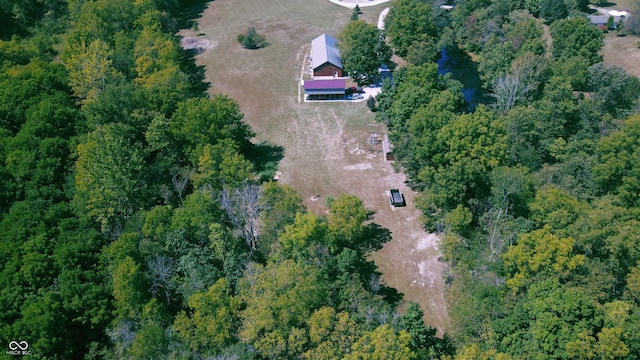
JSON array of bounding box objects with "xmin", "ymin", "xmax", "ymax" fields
[{"xmin": 0, "ymin": 0, "xmax": 455, "ymax": 359}]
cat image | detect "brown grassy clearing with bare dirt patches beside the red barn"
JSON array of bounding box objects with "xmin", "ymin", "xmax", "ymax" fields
[{"xmin": 180, "ymin": 0, "xmax": 449, "ymax": 333}]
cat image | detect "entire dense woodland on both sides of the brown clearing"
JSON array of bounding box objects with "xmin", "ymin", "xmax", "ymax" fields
[{"xmin": 0, "ymin": 0, "xmax": 640, "ymax": 359}]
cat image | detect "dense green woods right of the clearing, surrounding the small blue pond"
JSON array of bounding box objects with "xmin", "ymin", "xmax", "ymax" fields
[{"xmin": 377, "ymin": 0, "xmax": 640, "ymax": 359}]
